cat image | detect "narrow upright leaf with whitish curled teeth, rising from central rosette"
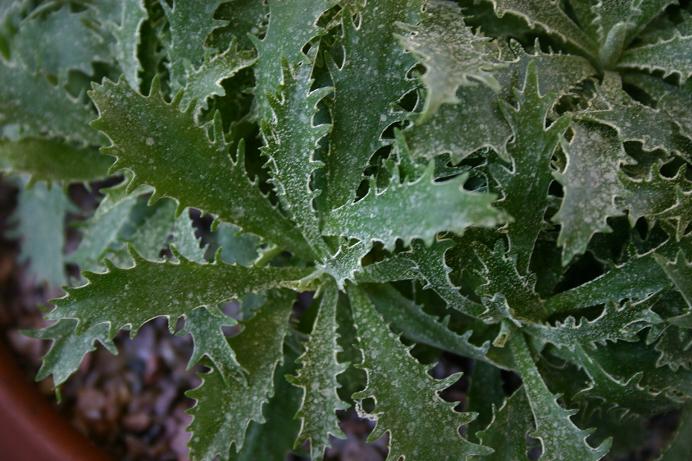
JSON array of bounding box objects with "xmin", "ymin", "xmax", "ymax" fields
[{"xmin": 262, "ymin": 61, "xmax": 331, "ymax": 255}]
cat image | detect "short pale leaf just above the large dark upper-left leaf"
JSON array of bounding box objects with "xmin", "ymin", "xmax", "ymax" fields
[{"xmin": 180, "ymin": 41, "xmax": 255, "ymax": 119}]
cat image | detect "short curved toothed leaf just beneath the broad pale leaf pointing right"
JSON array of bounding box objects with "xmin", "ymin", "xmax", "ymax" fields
[{"xmin": 403, "ymin": 240, "xmax": 486, "ymax": 318}]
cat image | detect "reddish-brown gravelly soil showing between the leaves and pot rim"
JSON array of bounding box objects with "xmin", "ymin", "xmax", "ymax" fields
[{"xmin": 0, "ymin": 177, "xmax": 672, "ymax": 461}]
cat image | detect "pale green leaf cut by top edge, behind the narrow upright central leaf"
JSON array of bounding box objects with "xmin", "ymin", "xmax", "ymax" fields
[{"xmin": 250, "ymin": 0, "xmax": 336, "ymax": 121}]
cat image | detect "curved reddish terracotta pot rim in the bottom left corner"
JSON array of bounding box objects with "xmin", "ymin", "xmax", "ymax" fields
[{"xmin": 0, "ymin": 341, "xmax": 110, "ymax": 461}]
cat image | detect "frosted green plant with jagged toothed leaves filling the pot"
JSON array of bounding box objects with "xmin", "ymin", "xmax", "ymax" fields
[{"xmin": 0, "ymin": 0, "xmax": 692, "ymax": 461}]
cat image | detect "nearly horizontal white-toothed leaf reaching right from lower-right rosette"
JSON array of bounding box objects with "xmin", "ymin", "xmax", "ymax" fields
[{"xmin": 523, "ymin": 298, "xmax": 663, "ymax": 349}]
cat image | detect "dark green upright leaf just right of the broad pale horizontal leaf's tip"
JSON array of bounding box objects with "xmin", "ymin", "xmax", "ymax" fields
[{"xmin": 491, "ymin": 60, "xmax": 570, "ymax": 273}]
